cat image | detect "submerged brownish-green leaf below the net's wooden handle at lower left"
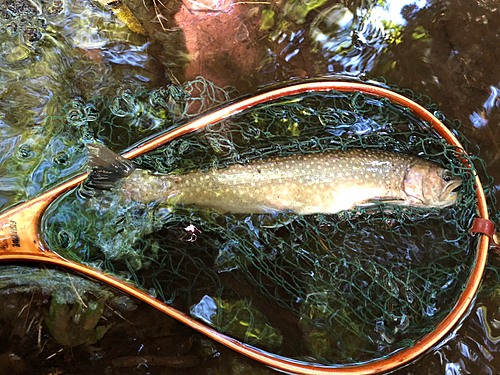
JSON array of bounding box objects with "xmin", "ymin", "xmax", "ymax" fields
[{"xmin": 45, "ymin": 298, "xmax": 111, "ymax": 347}]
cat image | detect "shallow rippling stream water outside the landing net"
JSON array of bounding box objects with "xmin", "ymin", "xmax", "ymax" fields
[{"xmin": 0, "ymin": 0, "xmax": 500, "ymax": 374}]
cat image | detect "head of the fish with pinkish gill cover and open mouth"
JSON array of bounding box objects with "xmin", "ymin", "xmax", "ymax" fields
[{"xmin": 403, "ymin": 161, "xmax": 462, "ymax": 207}]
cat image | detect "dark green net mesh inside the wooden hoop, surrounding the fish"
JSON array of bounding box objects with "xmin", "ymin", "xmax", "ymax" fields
[{"xmin": 42, "ymin": 86, "xmax": 477, "ymax": 365}]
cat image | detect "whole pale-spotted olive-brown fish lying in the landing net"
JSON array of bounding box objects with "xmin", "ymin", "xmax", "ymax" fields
[{"xmin": 87, "ymin": 144, "xmax": 462, "ymax": 215}]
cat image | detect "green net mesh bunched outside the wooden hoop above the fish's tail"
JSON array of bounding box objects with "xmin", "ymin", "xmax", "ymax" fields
[{"xmin": 61, "ymin": 77, "xmax": 235, "ymax": 150}]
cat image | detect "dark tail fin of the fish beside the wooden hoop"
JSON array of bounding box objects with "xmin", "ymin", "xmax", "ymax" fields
[{"xmin": 85, "ymin": 143, "xmax": 135, "ymax": 190}]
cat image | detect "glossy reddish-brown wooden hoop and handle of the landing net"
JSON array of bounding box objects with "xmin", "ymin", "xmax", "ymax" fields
[{"xmin": 0, "ymin": 81, "xmax": 489, "ymax": 375}]
